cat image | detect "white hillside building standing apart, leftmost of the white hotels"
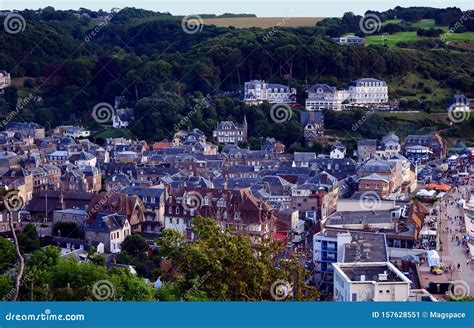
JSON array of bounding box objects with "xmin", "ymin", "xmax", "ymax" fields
[{"xmin": 244, "ymin": 80, "xmax": 296, "ymax": 104}]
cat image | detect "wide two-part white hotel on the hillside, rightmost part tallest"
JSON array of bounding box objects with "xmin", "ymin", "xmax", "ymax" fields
[{"xmin": 306, "ymin": 78, "xmax": 388, "ymax": 111}]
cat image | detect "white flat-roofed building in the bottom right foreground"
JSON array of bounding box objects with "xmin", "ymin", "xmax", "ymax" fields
[{"xmin": 333, "ymin": 262, "xmax": 411, "ymax": 302}]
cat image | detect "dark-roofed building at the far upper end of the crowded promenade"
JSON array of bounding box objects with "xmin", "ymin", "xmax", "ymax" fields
[{"xmin": 404, "ymin": 133, "xmax": 448, "ymax": 160}]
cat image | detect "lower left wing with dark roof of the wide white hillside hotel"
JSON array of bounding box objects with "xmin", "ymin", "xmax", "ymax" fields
[{"xmin": 306, "ymin": 84, "xmax": 350, "ymax": 111}]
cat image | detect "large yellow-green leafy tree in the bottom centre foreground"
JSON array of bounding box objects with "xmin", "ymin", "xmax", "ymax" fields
[{"xmin": 158, "ymin": 217, "xmax": 316, "ymax": 301}]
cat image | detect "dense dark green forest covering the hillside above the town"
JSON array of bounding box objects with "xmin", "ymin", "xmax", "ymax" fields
[{"xmin": 0, "ymin": 7, "xmax": 474, "ymax": 146}]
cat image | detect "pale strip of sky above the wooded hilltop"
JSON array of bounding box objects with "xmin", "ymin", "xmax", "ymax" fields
[{"xmin": 0, "ymin": 0, "xmax": 474, "ymax": 17}]
